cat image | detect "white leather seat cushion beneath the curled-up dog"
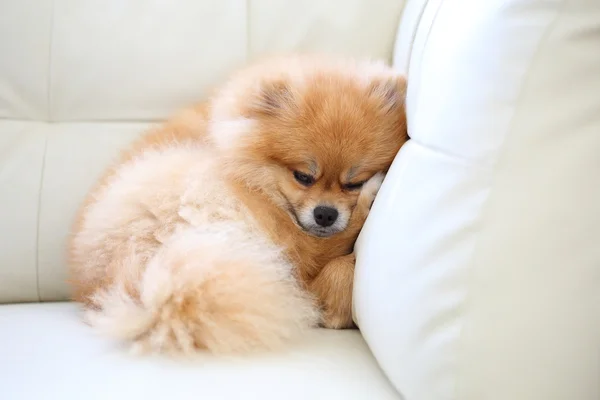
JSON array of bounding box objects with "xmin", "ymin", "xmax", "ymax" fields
[{"xmin": 0, "ymin": 303, "xmax": 401, "ymax": 400}]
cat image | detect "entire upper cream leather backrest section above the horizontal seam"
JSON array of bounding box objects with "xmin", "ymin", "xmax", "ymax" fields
[{"xmin": 0, "ymin": 0, "xmax": 403, "ymax": 121}]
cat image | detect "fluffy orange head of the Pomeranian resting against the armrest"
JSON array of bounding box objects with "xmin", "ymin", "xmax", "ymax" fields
[{"xmin": 211, "ymin": 57, "xmax": 407, "ymax": 237}]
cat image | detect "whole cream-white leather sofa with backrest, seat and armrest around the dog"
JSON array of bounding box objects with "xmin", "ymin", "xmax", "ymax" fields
[{"xmin": 0, "ymin": 0, "xmax": 600, "ymax": 400}]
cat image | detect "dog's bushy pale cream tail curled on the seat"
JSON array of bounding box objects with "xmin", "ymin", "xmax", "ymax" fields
[{"xmin": 86, "ymin": 226, "xmax": 319, "ymax": 354}]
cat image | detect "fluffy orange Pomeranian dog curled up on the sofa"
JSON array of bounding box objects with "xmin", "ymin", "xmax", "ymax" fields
[{"xmin": 69, "ymin": 56, "xmax": 408, "ymax": 354}]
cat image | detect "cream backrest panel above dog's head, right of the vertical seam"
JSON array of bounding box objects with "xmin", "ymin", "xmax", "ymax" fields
[{"xmin": 248, "ymin": 0, "xmax": 404, "ymax": 59}]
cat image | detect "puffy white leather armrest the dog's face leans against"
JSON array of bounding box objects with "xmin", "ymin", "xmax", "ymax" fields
[{"xmin": 354, "ymin": 0, "xmax": 600, "ymax": 400}]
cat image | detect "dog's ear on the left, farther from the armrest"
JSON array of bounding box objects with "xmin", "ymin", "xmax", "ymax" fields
[{"xmin": 250, "ymin": 80, "xmax": 294, "ymax": 117}]
